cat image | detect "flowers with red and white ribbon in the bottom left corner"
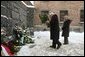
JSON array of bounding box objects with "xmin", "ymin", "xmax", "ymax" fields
[{"xmin": 1, "ymin": 28, "xmax": 15, "ymax": 56}]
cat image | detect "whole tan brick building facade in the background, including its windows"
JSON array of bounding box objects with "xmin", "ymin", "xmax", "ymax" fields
[{"xmin": 34, "ymin": 1, "xmax": 84, "ymax": 26}]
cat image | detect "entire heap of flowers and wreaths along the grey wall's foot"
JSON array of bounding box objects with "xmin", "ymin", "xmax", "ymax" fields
[{"xmin": 1, "ymin": 26, "xmax": 34, "ymax": 55}]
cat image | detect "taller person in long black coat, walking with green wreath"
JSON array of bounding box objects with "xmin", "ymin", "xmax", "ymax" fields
[{"xmin": 50, "ymin": 14, "xmax": 61, "ymax": 49}]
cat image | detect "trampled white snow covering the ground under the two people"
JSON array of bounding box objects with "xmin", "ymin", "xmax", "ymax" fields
[{"xmin": 17, "ymin": 31, "xmax": 84, "ymax": 56}]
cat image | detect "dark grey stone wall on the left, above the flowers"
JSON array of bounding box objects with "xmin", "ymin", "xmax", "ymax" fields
[{"xmin": 1, "ymin": 1, "xmax": 33, "ymax": 34}]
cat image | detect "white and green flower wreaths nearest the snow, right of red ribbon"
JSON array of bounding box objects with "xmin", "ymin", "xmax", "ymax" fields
[{"xmin": 14, "ymin": 28, "xmax": 33, "ymax": 46}]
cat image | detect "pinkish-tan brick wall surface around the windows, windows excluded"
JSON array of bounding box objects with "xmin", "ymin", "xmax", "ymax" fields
[{"xmin": 34, "ymin": 1, "xmax": 84, "ymax": 26}]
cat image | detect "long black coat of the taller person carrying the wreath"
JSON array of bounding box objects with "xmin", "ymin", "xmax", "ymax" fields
[{"xmin": 50, "ymin": 14, "xmax": 60, "ymax": 42}]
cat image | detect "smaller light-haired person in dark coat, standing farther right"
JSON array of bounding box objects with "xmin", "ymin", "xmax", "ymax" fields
[{"xmin": 62, "ymin": 16, "xmax": 72, "ymax": 44}]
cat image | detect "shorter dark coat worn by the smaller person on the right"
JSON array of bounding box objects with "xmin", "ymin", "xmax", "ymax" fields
[{"xmin": 62, "ymin": 19, "xmax": 71, "ymax": 37}]
